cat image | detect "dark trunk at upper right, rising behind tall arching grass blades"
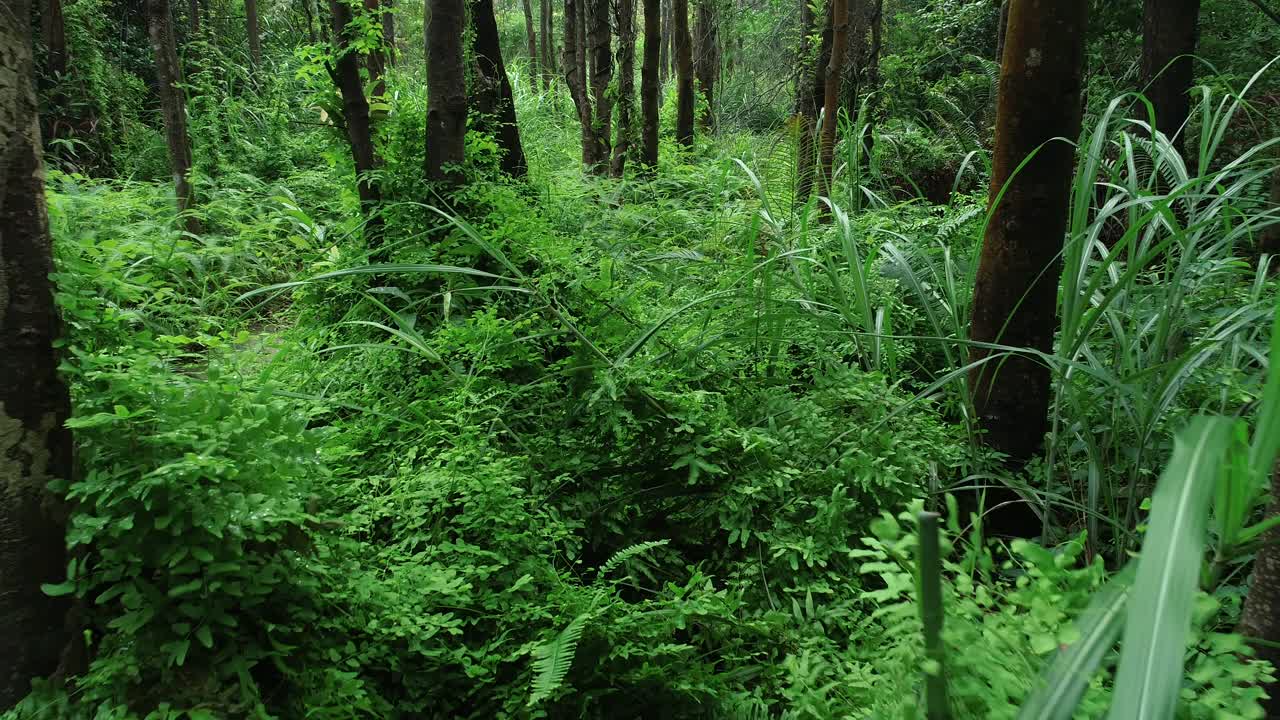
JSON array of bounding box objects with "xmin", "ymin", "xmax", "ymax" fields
[{"xmin": 1142, "ymin": 0, "xmax": 1199, "ymax": 156}]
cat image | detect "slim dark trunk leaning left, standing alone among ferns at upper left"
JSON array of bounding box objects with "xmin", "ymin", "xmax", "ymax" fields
[{"xmin": 146, "ymin": 0, "xmax": 200, "ymax": 233}]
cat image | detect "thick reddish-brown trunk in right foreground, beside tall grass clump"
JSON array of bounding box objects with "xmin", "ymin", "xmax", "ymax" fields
[{"xmin": 969, "ymin": 0, "xmax": 1089, "ymax": 527}]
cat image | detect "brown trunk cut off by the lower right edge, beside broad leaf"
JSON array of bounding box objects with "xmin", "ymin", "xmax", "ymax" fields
[{"xmin": 1238, "ymin": 465, "xmax": 1280, "ymax": 717}]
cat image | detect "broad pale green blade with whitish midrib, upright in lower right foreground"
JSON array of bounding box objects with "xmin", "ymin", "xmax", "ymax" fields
[{"xmin": 1108, "ymin": 416, "xmax": 1233, "ymax": 720}]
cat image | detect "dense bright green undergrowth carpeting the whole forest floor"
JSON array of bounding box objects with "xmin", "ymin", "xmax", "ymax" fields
[{"xmin": 13, "ymin": 15, "xmax": 1276, "ymax": 719}]
